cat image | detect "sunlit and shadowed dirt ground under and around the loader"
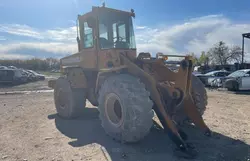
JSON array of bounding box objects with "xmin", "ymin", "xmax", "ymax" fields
[{"xmin": 0, "ymin": 84, "xmax": 250, "ymax": 161}]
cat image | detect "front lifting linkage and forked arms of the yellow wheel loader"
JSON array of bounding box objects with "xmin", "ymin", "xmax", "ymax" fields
[{"xmin": 133, "ymin": 53, "xmax": 211, "ymax": 158}]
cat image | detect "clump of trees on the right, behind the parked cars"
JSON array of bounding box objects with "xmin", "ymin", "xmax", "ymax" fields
[{"xmin": 189, "ymin": 41, "xmax": 242, "ymax": 66}]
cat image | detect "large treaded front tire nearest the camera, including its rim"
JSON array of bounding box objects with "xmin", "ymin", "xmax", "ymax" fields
[{"xmin": 98, "ymin": 74, "xmax": 154, "ymax": 142}]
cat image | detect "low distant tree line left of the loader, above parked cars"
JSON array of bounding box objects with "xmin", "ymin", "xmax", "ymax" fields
[{"xmin": 0, "ymin": 58, "xmax": 60, "ymax": 71}]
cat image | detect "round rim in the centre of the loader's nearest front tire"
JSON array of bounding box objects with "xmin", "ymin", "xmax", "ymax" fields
[{"xmin": 105, "ymin": 93, "xmax": 123, "ymax": 127}]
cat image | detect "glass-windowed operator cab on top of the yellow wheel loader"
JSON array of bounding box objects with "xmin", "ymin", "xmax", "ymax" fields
[{"xmin": 77, "ymin": 7, "xmax": 136, "ymax": 69}]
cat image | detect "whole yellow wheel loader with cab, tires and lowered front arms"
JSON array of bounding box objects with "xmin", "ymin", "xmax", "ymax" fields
[{"xmin": 48, "ymin": 6, "xmax": 211, "ymax": 158}]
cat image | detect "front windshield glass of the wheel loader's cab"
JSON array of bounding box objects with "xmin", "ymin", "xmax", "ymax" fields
[{"xmin": 99, "ymin": 12, "xmax": 136, "ymax": 49}]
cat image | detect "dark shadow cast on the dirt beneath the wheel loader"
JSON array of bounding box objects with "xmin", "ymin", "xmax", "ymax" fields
[{"xmin": 48, "ymin": 108, "xmax": 250, "ymax": 161}]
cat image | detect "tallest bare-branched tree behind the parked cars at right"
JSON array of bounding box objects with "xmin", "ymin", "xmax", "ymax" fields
[{"xmin": 209, "ymin": 41, "xmax": 241, "ymax": 65}]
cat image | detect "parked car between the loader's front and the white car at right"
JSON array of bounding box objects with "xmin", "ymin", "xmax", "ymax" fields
[{"xmin": 196, "ymin": 70, "xmax": 231, "ymax": 86}]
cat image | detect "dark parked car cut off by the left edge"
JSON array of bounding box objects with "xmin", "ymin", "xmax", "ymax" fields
[{"xmin": 0, "ymin": 69, "xmax": 27, "ymax": 84}]
